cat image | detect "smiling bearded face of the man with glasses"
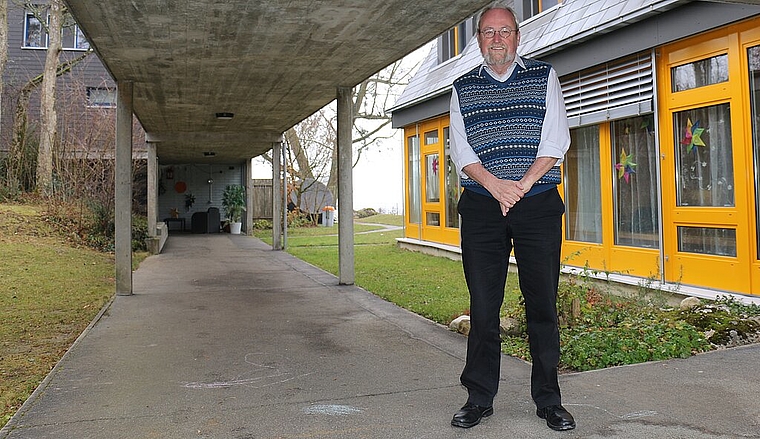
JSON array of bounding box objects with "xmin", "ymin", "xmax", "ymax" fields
[{"xmin": 478, "ymin": 9, "xmax": 520, "ymax": 69}]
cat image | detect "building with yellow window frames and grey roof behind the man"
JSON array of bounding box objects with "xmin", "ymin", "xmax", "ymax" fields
[{"xmin": 392, "ymin": 0, "xmax": 760, "ymax": 299}]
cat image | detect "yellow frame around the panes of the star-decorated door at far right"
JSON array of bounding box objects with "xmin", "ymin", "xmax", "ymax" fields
[{"xmin": 658, "ymin": 20, "xmax": 757, "ymax": 293}]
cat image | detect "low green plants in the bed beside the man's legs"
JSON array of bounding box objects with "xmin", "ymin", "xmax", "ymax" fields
[{"xmin": 502, "ymin": 274, "xmax": 732, "ymax": 371}]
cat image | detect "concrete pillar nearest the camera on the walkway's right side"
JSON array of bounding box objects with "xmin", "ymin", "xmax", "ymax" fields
[{"xmin": 337, "ymin": 87, "xmax": 354, "ymax": 285}]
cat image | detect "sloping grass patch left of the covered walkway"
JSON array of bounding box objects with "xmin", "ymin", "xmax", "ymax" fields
[{"xmin": 0, "ymin": 205, "xmax": 114, "ymax": 425}]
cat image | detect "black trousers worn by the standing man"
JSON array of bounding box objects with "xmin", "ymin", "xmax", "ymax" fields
[{"xmin": 458, "ymin": 188, "xmax": 565, "ymax": 408}]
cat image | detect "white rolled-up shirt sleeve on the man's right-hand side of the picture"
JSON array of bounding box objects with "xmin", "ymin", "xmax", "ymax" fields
[{"xmin": 540, "ymin": 68, "xmax": 570, "ymax": 166}]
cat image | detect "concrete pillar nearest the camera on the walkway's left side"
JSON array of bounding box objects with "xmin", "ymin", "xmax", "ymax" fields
[{"xmin": 114, "ymin": 81, "xmax": 133, "ymax": 296}]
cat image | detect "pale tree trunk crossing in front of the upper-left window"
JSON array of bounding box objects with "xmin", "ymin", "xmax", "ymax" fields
[{"xmin": 37, "ymin": 0, "xmax": 63, "ymax": 196}]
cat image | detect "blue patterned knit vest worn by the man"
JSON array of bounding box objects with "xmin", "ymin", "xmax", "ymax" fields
[{"xmin": 454, "ymin": 59, "xmax": 560, "ymax": 192}]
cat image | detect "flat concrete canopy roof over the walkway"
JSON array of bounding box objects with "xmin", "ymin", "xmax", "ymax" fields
[{"xmin": 65, "ymin": 0, "xmax": 488, "ymax": 163}]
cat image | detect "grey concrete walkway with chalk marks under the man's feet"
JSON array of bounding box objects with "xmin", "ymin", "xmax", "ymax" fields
[{"xmin": 0, "ymin": 234, "xmax": 760, "ymax": 439}]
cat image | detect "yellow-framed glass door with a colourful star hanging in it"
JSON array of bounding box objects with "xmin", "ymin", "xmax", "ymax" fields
[{"xmin": 660, "ymin": 33, "xmax": 751, "ymax": 293}]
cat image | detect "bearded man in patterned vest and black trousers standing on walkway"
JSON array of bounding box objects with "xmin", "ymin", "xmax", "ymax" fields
[{"xmin": 450, "ymin": 0, "xmax": 575, "ymax": 431}]
